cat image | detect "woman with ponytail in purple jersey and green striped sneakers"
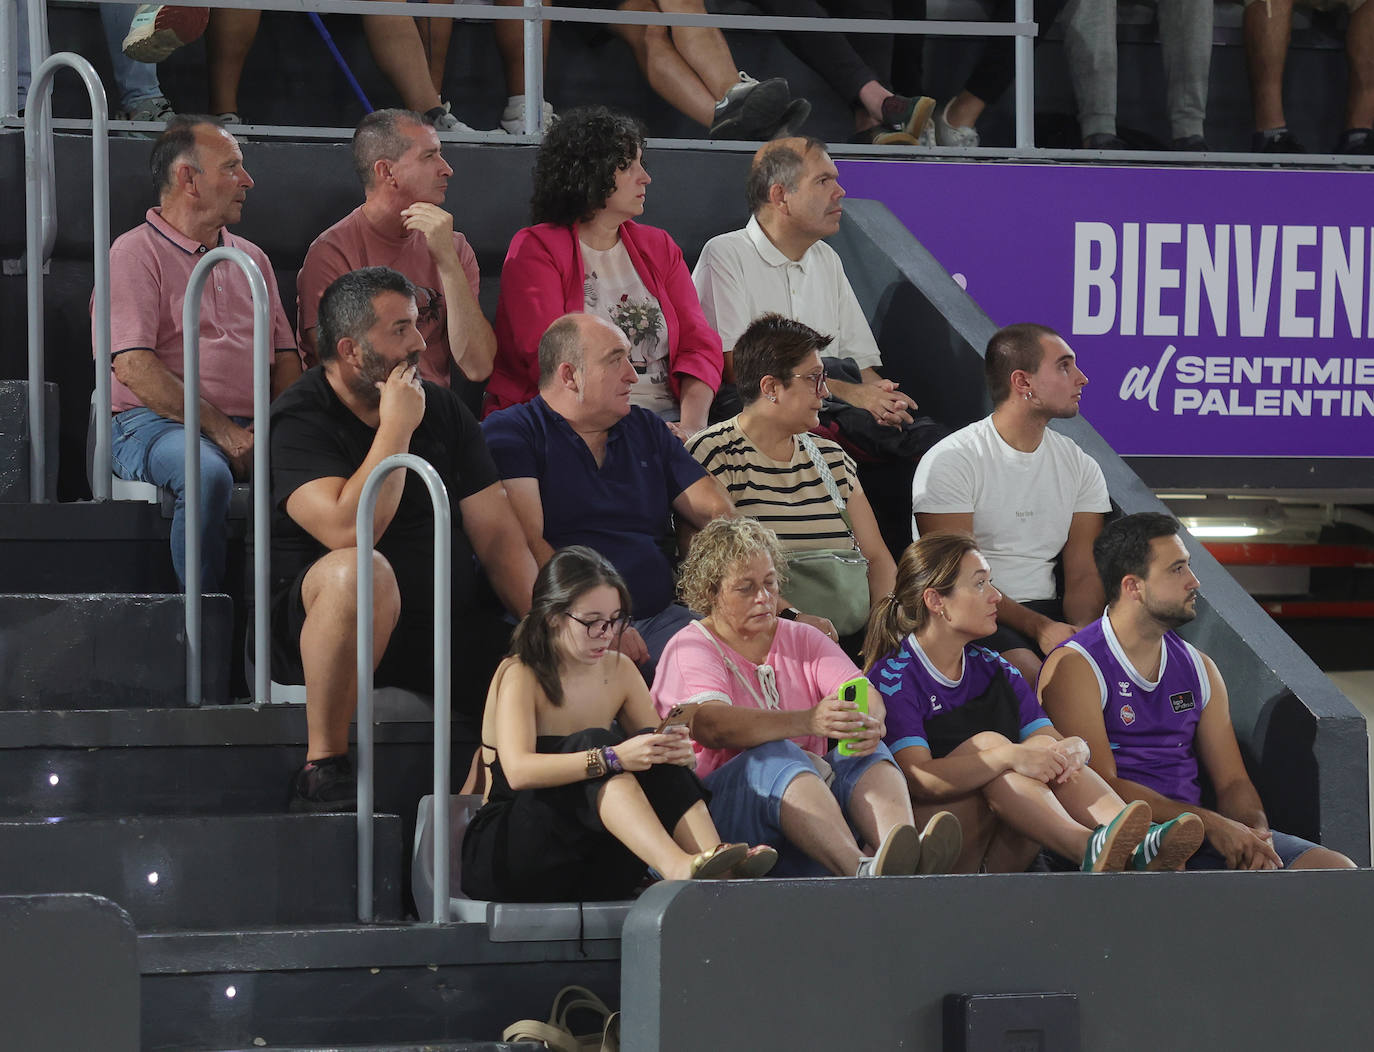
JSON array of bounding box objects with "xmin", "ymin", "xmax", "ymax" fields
[{"xmin": 864, "ymin": 533, "xmax": 1202, "ymax": 872}]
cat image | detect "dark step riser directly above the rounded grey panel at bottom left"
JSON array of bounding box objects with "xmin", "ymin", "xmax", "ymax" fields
[{"xmin": 0, "ymin": 814, "xmax": 403, "ymax": 931}]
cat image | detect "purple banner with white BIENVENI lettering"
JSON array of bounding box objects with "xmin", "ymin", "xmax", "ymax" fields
[{"xmin": 840, "ymin": 161, "xmax": 1374, "ymax": 457}]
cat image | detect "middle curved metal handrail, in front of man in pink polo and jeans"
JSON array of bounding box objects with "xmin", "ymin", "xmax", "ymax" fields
[{"xmin": 181, "ymin": 246, "xmax": 272, "ymax": 706}]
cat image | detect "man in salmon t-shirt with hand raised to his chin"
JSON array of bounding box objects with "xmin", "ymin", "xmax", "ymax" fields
[{"xmin": 295, "ymin": 110, "xmax": 496, "ymax": 387}]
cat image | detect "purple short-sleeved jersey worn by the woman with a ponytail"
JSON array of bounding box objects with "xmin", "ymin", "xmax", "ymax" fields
[{"xmin": 868, "ymin": 636, "xmax": 1051, "ymax": 754}]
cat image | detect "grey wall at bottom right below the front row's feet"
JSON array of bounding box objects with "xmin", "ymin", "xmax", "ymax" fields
[{"xmin": 621, "ymin": 871, "xmax": 1374, "ymax": 1052}]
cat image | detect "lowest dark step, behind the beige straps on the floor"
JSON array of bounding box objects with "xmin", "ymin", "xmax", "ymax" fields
[{"xmin": 139, "ymin": 924, "xmax": 620, "ymax": 1052}]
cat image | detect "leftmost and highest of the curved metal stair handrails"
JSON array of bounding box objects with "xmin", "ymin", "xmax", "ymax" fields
[{"xmin": 23, "ymin": 51, "xmax": 110, "ymax": 504}]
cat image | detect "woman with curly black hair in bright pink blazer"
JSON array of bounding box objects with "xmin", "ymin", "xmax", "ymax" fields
[{"xmin": 484, "ymin": 106, "xmax": 724, "ymax": 438}]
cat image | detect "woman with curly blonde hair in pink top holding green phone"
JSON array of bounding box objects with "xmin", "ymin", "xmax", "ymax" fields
[{"xmin": 653, "ymin": 518, "xmax": 960, "ymax": 876}]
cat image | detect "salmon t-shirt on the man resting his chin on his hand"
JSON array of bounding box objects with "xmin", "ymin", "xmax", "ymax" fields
[{"xmin": 295, "ymin": 205, "xmax": 481, "ymax": 387}]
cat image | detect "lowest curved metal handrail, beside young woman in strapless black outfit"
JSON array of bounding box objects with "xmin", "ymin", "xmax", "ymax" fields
[{"xmin": 354, "ymin": 453, "xmax": 453, "ymax": 924}]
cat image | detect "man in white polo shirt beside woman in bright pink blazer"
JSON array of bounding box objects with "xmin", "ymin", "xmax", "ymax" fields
[{"xmin": 692, "ymin": 137, "xmax": 916, "ymax": 427}]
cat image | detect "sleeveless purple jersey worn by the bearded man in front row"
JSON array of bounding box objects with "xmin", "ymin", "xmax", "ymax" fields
[{"xmin": 1063, "ymin": 617, "xmax": 1212, "ymax": 803}]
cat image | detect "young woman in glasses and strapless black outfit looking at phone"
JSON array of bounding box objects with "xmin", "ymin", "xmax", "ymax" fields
[{"xmin": 463, "ymin": 547, "xmax": 778, "ymax": 902}]
